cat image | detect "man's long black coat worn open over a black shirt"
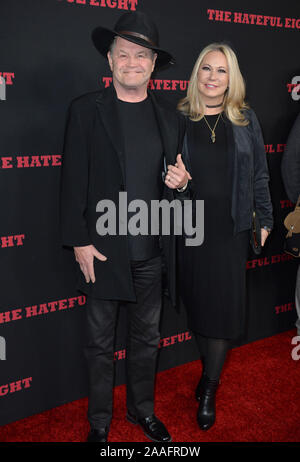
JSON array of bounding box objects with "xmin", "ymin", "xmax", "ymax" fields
[{"xmin": 60, "ymin": 87, "xmax": 184, "ymax": 304}]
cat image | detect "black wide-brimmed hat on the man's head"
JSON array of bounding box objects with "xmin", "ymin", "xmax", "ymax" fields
[{"xmin": 92, "ymin": 11, "xmax": 174, "ymax": 68}]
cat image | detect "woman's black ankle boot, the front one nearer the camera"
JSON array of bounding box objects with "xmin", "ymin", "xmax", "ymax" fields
[{"xmin": 197, "ymin": 376, "xmax": 219, "ymax": 431}]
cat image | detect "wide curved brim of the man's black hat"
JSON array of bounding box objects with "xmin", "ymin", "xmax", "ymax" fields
[{"xmin": 92, "ymin": 26, "xmax": 175, "ymax": 69}]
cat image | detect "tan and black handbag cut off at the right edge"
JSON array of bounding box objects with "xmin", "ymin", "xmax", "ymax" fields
[{"xmin": 283, "ymin": 196, "xmax": 300, "ymax": 258}]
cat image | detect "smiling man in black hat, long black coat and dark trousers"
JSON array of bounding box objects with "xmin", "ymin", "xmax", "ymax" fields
[{"xmin": 61, "ymin": 12, "xmax": 189, "ymax": 442}]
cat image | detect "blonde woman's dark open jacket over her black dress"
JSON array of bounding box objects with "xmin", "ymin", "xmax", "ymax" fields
[{"xmin": 183, "ymin": 109, "xmax": 273, "ymax": 234}]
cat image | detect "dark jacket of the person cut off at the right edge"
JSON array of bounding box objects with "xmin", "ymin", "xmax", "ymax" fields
[{"xmin": 281, "ymin": 113, "xmax": 300, "ymax": 203}]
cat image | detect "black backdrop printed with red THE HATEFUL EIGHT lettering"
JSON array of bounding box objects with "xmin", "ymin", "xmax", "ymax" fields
[{"xmin": 0, "ymin": 0, "xmax": 300, "ymax": 424}]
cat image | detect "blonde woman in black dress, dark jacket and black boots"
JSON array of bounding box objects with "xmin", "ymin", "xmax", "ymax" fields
[{"xmin": 178, "ymin": 43, "xmax": 273, "ymax": 430}]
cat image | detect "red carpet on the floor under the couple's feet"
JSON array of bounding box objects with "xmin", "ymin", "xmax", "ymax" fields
[{"xmin": 0, "ymin": 329, "xmax": 300, "ymax": 442}]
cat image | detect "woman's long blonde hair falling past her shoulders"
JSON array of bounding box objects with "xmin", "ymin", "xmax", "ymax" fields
[{"xmin": 178, "ymin": 43, "xmax": 249, "ymax": 125}]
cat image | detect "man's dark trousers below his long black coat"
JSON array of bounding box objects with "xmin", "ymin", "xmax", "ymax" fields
[{"xmin": 85, "ymin": 256, "xmax": 162, "ymax": 428}]
